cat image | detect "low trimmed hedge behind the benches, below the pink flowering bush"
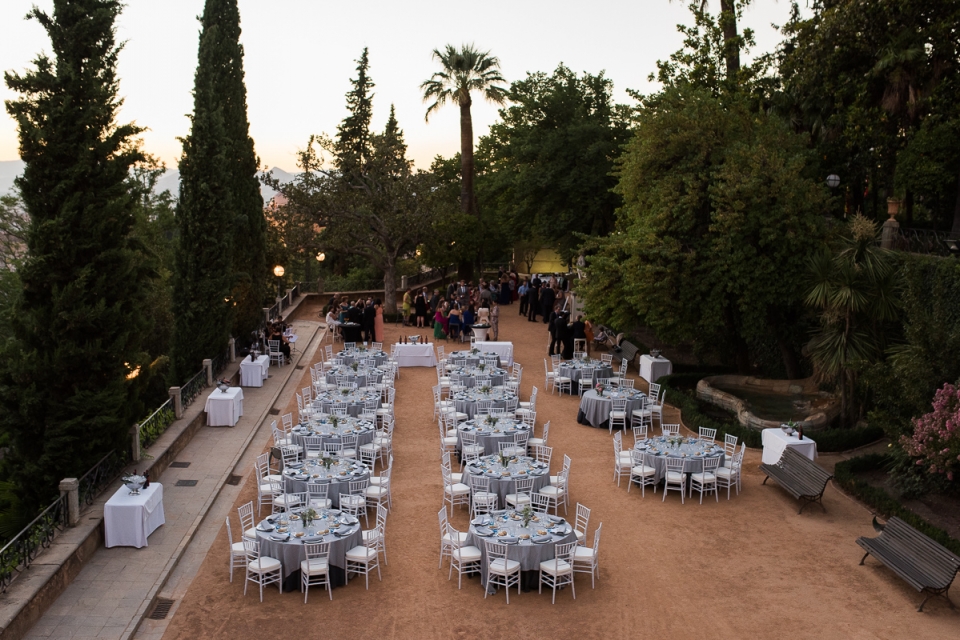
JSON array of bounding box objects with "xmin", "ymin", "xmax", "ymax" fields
[{"xmin": 832, "ymin": 456, "xmax": 960, "ymax": 554}]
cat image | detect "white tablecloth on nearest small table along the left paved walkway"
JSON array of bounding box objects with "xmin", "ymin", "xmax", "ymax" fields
[{"xmin": 103, "ymin": 482, "xmax": 164, "ymax": 549}]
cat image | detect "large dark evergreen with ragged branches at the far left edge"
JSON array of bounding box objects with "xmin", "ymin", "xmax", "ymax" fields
[{"xmin": 0, "ymin": 0, "xmax": 155, "ymax": 506}]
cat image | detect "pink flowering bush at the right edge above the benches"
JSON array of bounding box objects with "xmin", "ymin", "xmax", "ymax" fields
[{"xmin": 900, "ymin": 383, "xmax": 960, "ymax": 482}]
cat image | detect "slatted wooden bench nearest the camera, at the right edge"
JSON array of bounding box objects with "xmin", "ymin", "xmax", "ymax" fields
[{"xmin": 857, "ymin": 517, "xmax": 960, "ymax": 611}]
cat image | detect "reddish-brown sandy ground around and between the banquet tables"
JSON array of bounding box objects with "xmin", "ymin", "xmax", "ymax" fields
[{"xmin": 165, "ymin": 306, "xmax": 960, "ymax": 640}]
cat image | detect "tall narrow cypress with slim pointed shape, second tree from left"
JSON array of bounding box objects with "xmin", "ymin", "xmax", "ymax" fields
[{"xmin": 173, "ymin": 0, "xmax": 242, "ymax": 382}]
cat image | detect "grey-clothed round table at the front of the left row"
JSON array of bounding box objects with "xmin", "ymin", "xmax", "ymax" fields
[{"xmin": 257, "ymin": 509, "xmax": 363, "ymax": 593}]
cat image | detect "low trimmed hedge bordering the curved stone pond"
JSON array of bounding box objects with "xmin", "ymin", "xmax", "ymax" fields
[{"xmin": 657, "ymin": 372, "xmax": 883, "ymax": 453}]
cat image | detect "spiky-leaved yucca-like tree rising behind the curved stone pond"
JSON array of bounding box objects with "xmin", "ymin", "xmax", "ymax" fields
[{"xmin": 806, "ymin": 215, "xmax": 900, "ymax": 423}]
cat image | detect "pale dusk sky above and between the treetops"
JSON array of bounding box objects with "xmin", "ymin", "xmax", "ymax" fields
[{"xmin": 0, "ymin": 0, "xmax": 790, "ymax": 171}]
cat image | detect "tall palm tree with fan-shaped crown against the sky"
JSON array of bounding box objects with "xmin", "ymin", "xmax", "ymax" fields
[{"xmin": 420, "ymin": 44, "xmax": 507, "ymax": 226}]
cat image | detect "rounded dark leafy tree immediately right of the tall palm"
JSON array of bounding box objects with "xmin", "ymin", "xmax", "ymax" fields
[{"xmin": 478, "ymin": 64, "xmax": 630, "ymax": 260}]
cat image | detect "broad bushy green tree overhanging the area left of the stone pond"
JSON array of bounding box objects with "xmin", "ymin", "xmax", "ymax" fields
[{"xmin": 583, "ymin": 86, "xmax": 826, "ymax": 375}]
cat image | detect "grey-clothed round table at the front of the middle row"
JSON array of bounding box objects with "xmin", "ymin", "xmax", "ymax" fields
[{"xmin": 465, "ymin": 510, "xmax": 577, "ymax": 591}]
